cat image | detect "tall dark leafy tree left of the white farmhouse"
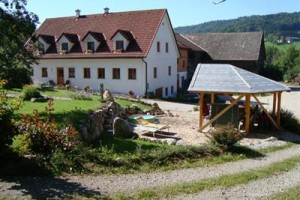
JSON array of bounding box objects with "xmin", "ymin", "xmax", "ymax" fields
[{"xmin": 0, "ymin": 0, "xmax": 38, "ymax": 87}]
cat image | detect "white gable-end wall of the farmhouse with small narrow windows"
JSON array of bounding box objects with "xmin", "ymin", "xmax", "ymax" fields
[{"xmin": 145, "ymin": 15, "xmax": 179, "ymax": 97}]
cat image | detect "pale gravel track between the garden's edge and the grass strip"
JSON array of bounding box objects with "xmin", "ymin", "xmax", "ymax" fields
[{"xmin": 0, "ymin": 145, "xmax": 300, "ymax": 199}]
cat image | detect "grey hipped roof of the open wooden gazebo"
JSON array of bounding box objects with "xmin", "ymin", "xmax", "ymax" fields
[{"xmin": 188, "ymin": 64, "xmax": 291, "ymax": 94}]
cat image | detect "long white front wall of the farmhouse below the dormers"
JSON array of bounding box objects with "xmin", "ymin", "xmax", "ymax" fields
[{"xmin": 33, "ymin": 59, "xmax": 146, "ymax": 96}]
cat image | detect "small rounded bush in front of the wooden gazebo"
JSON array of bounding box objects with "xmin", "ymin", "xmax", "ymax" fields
[{"xmin": 211, "ymin": 124, "xmax": 243, "ymax": 150}]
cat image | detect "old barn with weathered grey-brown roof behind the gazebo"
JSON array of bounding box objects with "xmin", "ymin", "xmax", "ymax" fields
[{"xmin": 176, "ymin": 32, "xmax": 265, "ymax": 81}]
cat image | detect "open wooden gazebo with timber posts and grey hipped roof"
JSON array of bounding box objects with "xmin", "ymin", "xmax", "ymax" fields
[{"xmin": 188, "ymin": 64, "xmax": 291, "ymax": 133}]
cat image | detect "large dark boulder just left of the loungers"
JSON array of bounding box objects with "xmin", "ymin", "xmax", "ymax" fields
[{"xmin": 113, "ymin": 117, "xmax": 133, "ymax": 138}]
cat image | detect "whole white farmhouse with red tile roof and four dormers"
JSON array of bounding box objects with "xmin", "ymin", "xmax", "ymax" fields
[{"xmin": 31, "ymin": 8, "xmax": 180, "ymax": 97}]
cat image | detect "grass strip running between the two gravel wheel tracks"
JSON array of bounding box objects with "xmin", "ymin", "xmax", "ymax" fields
[{"xmin": 113, "ymin": 156, "xmax": 300, "ymax": 200}]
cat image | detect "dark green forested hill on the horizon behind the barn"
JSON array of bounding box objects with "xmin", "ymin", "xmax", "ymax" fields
[{"xmin": 175, "ymin": 12, "xmax": 300, "ymax": 37}]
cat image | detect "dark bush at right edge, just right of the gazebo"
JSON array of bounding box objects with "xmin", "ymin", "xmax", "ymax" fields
[{"xmin": 280, "ymin": 109, "xmax": 300, "ymax": 135}]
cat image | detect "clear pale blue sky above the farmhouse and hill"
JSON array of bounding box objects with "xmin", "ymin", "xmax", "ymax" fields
[{"xmin": 27, "ymin": 0, "xmax": 300, "ymax": 28}]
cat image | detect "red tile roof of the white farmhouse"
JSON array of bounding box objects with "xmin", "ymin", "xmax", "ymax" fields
[{"xmin": 35, "ymin": 9, "xmax": 167, "ymax": 58}]
